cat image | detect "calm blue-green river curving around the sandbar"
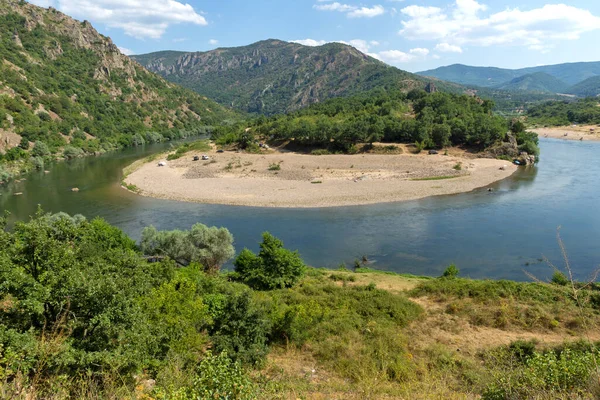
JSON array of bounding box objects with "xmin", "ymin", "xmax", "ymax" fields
[{"xmin": 0, "ymin": 139, "xmax": 600, "ymax": 280}]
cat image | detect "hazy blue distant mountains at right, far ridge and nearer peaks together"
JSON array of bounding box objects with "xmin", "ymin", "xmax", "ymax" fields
[{"xmin": 418, "ymin": 62, "xmax": 600, "ymax": 97}]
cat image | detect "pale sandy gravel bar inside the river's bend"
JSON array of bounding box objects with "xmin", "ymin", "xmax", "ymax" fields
[{"xmin": 125, "ymin": 148, "xmax": 517, "ymax": 208}]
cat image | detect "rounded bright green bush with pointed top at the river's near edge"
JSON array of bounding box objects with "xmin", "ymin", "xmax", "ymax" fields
[{"xmin": 234, "ymin": 232, "xmax": 306, "ymax": 290}]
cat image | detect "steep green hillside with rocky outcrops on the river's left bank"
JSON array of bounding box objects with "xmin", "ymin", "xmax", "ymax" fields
[{"xmin": 0, "ymin": 0, "xmax": 237, "ymax": 160}]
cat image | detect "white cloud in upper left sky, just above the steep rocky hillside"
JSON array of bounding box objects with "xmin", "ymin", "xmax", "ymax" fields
[{"xmin": 34, "ymin": 0, "xmax": 208, "ymax": 39}]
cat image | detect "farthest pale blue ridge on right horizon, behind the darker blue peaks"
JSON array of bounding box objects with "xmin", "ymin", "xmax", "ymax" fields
[{"xmin": 418, "ymin": 62, "xmax": 600, "ymax": 87}]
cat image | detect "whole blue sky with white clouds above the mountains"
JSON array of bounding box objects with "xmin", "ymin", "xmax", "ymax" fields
[{"xmin": 31, "ymin": 0, "xmax": 600, "ymax": 72}]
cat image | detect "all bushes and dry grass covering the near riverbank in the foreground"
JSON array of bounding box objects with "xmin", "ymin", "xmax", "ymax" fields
[{"xmin": 0, "ymin": 211, "xmax": 600, "ymax": 399}]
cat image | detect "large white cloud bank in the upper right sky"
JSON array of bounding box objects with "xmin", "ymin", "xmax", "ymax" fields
[{"xmin": 399, "ymin": 0, "xmax": 600, "ymax": 53}]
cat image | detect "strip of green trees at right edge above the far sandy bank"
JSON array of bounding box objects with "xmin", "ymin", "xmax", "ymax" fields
[{"xmin": 527, "ymin": 97, "xmax": 600, "ymax": 126}]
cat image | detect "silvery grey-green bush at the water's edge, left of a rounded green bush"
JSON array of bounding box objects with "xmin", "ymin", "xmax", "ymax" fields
[{"xmin": 140, "ymin": 224, "xmax": 235, "ymax": 272}]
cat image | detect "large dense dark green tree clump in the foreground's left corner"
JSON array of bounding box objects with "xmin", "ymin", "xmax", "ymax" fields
[{"xmin": 0, "ymin": 208, "xmax": 176, "ymax": 376}]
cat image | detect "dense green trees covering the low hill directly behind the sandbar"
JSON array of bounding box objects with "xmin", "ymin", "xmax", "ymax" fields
[{"xmin": 215, "ymin": 90, "xmax": 535, "ymax": 152}]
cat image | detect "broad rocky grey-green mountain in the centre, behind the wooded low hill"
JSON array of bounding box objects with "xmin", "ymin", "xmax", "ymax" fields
[{"xmin": 132, "ymin": 39, "xmax": 462, "ymax": 115}]
